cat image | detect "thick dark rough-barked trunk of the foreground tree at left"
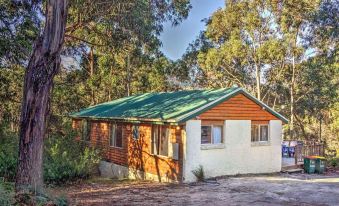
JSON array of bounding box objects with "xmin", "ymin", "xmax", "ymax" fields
[{"xmin": 15, "ymin": 0, "xmax": 68, "ymax": 194}]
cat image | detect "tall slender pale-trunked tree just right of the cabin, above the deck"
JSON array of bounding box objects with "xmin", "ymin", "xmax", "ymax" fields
[{"xmin": 271, "ymin": 0, "xmax": 319, "ymax": 139}]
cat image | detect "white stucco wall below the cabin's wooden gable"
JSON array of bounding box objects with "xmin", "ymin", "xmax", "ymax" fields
[{"xmin": 184, "ymin": 120, "xmax": 282, "ymax": 182}]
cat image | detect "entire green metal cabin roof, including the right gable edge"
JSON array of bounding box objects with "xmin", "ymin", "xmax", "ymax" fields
[{"xmin": 70, "ymin": 87, "xmax": 287, "ymax": 123}]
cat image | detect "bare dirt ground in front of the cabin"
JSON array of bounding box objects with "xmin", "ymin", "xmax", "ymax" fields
[{"xmin": 52, "ymin": 174, "xmax": 339, "ymax": 205}]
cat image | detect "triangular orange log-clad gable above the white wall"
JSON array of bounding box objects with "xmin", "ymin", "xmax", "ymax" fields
[{"xmin": 197, "ymin": 94, "xmax": 278, "ymax": 121}]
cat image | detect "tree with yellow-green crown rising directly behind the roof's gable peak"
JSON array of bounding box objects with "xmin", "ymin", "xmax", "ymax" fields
[{"xmin": 199, "ymin": 0, "xmax": 290, "ymax": 100}]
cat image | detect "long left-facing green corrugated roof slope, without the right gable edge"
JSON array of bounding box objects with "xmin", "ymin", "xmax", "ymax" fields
[{"xmin": 71, "ymin": 88, "xmax": 237, "ymax": 121}]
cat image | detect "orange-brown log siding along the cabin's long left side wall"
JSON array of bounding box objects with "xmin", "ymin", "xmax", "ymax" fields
[{"xmin": 72, "ymin": 119, "xmax": 183, "ymax": 181}]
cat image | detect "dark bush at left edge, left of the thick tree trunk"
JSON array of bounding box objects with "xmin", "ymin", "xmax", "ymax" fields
[{"xmin": 0, "ymin": 127, "xmax": 19, "ymax": 181}]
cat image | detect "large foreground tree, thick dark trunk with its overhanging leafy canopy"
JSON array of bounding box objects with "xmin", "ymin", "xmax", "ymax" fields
[{"xmin": 16, "ymin": 0, "xmax": 190, "ymax": 193}]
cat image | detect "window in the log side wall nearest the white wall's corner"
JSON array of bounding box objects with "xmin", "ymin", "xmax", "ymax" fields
[{"xmin": 152, "ymin": 125, "xmax": 170, "ymax": 156}]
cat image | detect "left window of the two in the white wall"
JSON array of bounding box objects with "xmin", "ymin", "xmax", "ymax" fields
[{"xmin": 201, "ymin": 125, "xmax": 223, "ymax": 144}]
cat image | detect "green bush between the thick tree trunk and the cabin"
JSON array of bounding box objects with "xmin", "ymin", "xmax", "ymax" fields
[{"xmin": 44, "ymin": 129, "xmax": 100, "ymax": 184}]
